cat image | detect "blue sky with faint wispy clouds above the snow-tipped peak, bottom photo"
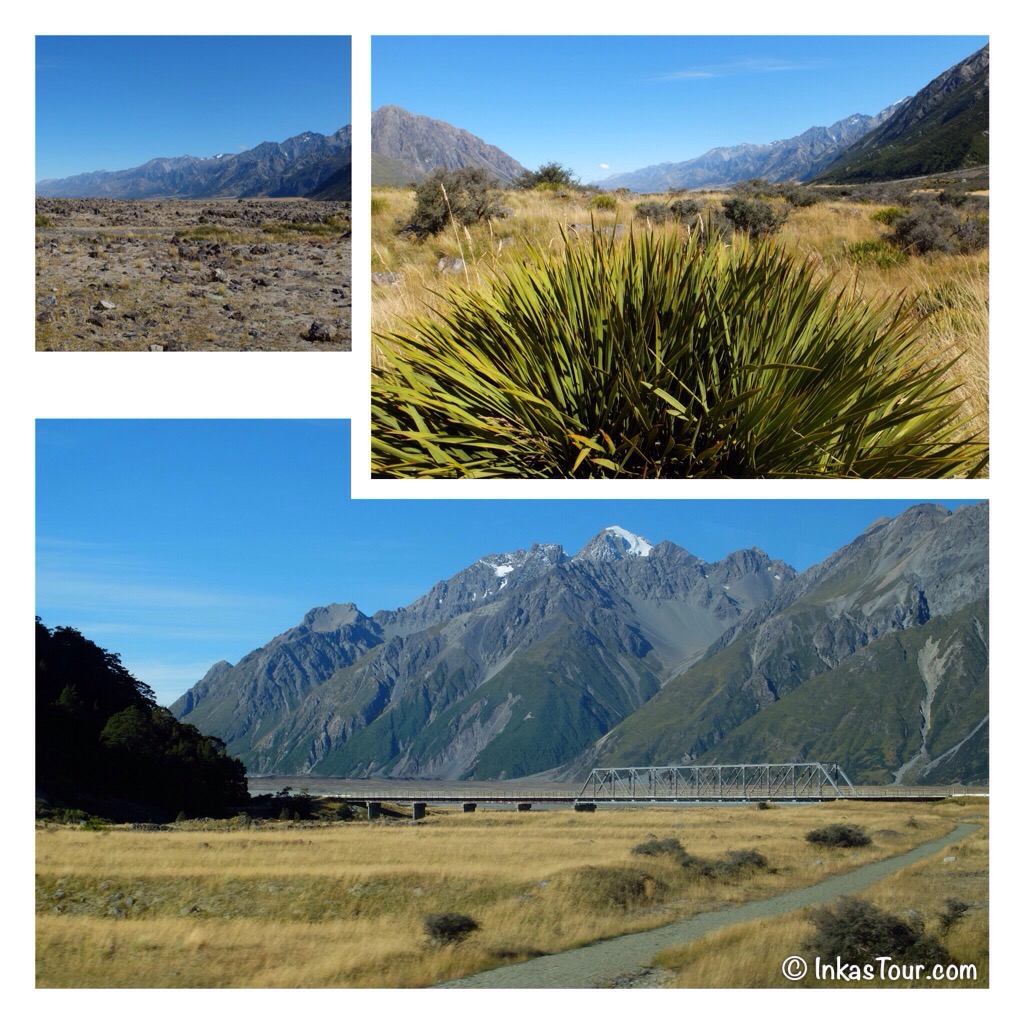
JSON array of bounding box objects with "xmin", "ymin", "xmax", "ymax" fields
[{"xmin": 36, "ymin": 420, "xmax": 983, "ymax": 703}]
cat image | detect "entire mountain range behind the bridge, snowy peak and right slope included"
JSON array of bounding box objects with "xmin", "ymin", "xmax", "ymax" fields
[{"xmin": 171, "ymin": 504, "xmax": 988, "ymax": 783}]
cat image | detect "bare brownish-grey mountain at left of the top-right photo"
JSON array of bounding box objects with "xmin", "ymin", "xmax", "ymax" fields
[{"xmin": 371, "ymin": 106, "xmax": 525, "ymax": 184}]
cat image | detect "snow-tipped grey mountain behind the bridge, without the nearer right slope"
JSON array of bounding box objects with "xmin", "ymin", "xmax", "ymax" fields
[{"xmin": 172, "ymin": 527, "xmax": 794, "ymax": 778}]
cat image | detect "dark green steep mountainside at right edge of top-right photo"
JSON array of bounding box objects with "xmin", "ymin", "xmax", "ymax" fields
[{"xmin": 819, "ymin": 46, "xmax": 988, "ymax": 182}]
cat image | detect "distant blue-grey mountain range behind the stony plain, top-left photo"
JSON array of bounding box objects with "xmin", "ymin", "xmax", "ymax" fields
[{"xmin": 36, "ymin": 126, "xmax": 352, "ymax": 202}]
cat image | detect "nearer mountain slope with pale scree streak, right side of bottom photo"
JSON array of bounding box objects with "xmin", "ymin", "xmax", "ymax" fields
[{"xmin": 566, "ymin": 505, "xmax": 988, "ymax": 783}]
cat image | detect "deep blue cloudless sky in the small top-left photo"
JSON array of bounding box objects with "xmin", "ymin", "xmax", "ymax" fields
[{"xmin": 36, "ymin": 36, "xmax": 351, "ymax": 181}]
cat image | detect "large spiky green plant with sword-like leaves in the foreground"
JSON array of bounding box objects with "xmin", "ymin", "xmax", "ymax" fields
[{"xmin": 372, "ymin": 231, "xmax": 986, "ymax": 478}]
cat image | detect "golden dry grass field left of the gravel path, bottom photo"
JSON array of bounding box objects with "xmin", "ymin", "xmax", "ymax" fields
[{"xmin": 37, "ymin": 801, "xmax": 985, "ymax": 988}]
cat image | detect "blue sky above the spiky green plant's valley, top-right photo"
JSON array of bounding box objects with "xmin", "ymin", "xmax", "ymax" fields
[{"xmin": 372, "ymin": 35, "xmax": 987, "ymax": 181}]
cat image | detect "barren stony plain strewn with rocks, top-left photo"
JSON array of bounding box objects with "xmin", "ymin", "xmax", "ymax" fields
[{"xmin": 35, "ymin": 198, "xmax": 351, "ymax": 351}]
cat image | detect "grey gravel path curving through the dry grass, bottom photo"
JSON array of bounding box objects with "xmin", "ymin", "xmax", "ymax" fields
[{"xmin": 437, "ymin": 821, "xmax": 978, "ymax": 988}]
